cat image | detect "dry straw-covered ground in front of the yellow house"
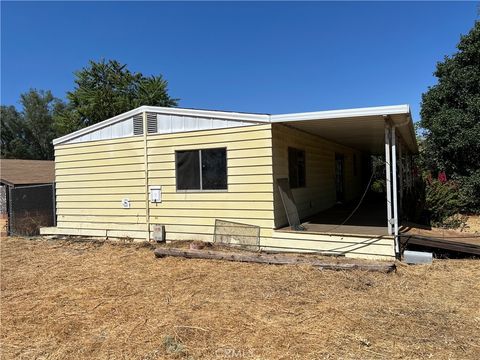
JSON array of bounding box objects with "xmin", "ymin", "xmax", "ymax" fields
[{"xmin": 1, "ymin": 238, "xmax": 480, "ymax": 359}]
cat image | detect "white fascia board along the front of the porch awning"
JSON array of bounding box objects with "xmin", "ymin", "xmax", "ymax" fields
[{"xmin": 271, "ymin": 105, "xmax": 410, "ymax": 122}]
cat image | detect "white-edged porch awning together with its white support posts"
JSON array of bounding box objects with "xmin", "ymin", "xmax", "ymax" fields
[{"xmin": 270, "ymin": 105, "xmax": 418, "ymax": 257}]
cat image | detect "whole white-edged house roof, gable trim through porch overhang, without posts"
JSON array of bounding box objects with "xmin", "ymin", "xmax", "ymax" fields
[{"xmin": 53, "ymin": 105, "xmax": 418, "ymax": 154}]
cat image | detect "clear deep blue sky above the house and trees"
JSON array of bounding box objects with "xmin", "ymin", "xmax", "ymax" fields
[{"xmin": 1, "ymin": 2, "xmax": 479, "ymax": 120}]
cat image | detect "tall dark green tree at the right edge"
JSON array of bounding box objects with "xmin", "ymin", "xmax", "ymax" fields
[{"xmin": 420, "ymin": 21, "xmax": 480, "ymax": 212}]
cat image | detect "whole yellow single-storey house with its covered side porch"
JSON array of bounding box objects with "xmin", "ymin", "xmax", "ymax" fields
[{"xmin": 41, "ymin": 105, "xmax": 417, "ymax": 259}]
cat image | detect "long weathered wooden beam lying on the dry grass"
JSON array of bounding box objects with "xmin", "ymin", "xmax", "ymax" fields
[{"xmin": 154, "ymin": 248, "xmax": 395, "ymax": 272}]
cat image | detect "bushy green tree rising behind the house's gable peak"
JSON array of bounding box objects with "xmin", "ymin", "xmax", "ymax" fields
[{"xmin": 60, "ymin": 60, "xmax": 177, "ymax": 131}]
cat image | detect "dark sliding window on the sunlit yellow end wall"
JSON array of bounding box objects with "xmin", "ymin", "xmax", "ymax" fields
[{"xmin": 175, "ymin": 148, "xmax": 227, "ymax": 190}]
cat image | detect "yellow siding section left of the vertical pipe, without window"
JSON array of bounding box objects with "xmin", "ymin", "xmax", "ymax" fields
[{"xmin": 55, "ymin": 137, "xmax": 146, "ymax": 233}]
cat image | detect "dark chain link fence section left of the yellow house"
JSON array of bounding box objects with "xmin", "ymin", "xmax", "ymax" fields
[{"xmin": 9, "ymin": 184, "xmax": 56, "ymax": 236}]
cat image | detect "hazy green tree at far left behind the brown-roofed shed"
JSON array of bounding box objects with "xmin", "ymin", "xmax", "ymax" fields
[{"xmin": 1, "ymin": 89, "xmax": 62, "ymax": 160}]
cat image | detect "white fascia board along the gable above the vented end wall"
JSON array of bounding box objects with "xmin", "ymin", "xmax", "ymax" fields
[{"xmin": 53, "ymin": 106, "xmax": 270, "ymax": 145}]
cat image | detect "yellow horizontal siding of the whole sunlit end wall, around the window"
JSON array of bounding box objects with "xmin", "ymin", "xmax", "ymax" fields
[{"xmin": 55, "ymin": 125, "xmax": 273, "ymax": 245}]
